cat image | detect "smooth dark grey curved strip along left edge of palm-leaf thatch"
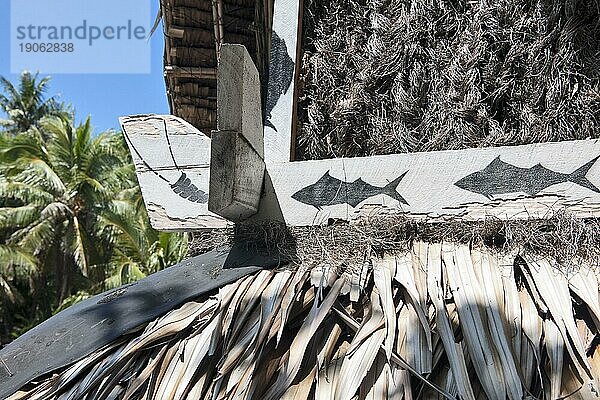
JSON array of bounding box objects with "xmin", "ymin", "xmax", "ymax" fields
[{"xmin": 0, "ymin": 249, "xmax": 274, "ymax": 398}]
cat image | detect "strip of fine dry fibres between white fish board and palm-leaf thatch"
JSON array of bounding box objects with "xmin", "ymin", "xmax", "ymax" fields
[{"xmin": 189, "ymin": 212, "xmax": 600, "ymax": 273}]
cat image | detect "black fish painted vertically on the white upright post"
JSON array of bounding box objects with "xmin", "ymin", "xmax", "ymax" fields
[{"xmin": 265, "ymin": 31, "xmax": 294, "ymax": 131}]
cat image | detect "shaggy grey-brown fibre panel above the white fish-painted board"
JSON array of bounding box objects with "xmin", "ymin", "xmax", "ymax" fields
[{"xmin": 297, "ymin": 0, "xmax": 600, "ymax": 159}]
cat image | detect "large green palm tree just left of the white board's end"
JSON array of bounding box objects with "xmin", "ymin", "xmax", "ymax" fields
[{"xmin": 0, "ymin": 117, "xmax": 124, "ymax": 300}]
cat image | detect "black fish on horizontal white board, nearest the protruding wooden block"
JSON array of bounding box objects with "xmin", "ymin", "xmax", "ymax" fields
[{"xmin": 292, "ymin": 171, "xmax": 408, "ymax": 210}]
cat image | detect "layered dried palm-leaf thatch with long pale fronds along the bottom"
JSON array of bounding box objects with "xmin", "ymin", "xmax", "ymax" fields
[{"xmin": 10, "ymin": 242, "xmax": 600, "ymax": 400}]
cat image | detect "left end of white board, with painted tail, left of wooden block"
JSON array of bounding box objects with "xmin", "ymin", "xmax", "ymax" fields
[{"xmin": 119, "ymin": 115, "xmax": 229, "ymax": 231}]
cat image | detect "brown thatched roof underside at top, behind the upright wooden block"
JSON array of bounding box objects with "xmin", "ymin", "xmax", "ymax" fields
[{"xmin": 160, "ymin": 0, "xmax": 273, "ymax": 134}]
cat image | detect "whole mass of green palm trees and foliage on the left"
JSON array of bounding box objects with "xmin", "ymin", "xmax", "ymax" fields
[{"xmin": 0, "ymin": 76, "xmax": 187, "ymax": 340}]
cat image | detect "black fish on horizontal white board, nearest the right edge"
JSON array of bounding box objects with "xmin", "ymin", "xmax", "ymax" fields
[{"xmin": 455, "ymin": 156, "xmax": 600, "ymax": 199}]
